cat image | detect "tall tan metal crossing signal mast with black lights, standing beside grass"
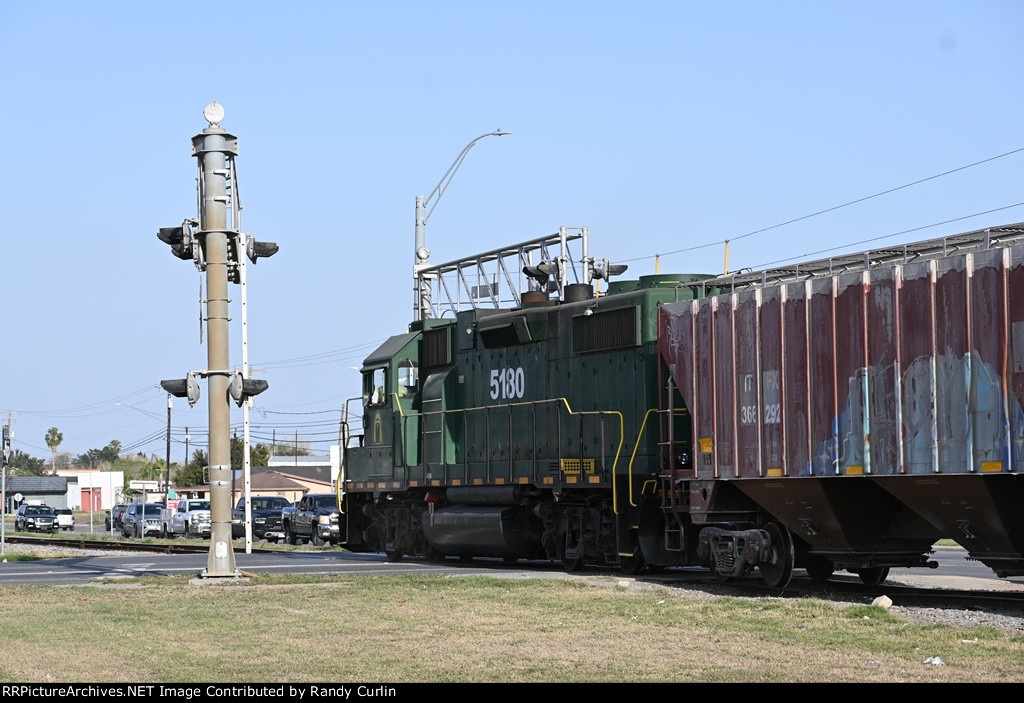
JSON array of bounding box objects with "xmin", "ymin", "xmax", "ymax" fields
[{"xmin": 157, "ymin": 102, "xmax": 279, "ymax": 577}]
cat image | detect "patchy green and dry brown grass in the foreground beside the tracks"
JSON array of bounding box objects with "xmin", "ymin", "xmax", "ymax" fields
[{"xmin": 0, "ymin": 575, "xmax": 1024, "ymax": 683}]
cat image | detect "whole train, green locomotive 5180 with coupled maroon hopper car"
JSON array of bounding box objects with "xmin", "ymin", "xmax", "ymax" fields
[{"xmin": 340, "ymin": 224, "xmax": 1024, "ymax": 585}]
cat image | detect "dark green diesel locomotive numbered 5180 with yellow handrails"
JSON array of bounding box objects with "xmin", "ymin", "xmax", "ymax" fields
[{"xmin": 341, "ymin": 228, "xmax": 708, "ymax": 570}]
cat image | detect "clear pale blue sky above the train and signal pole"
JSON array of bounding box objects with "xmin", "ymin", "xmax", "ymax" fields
[{"xmin": 0, "ymin": 0, "xmax": 1024, "ymax": 462}]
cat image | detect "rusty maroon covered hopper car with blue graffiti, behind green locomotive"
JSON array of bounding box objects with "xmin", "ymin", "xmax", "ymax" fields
[{"xmin": 659, "ymin": 224, "xmax": 1024, "ymax": 582}]
